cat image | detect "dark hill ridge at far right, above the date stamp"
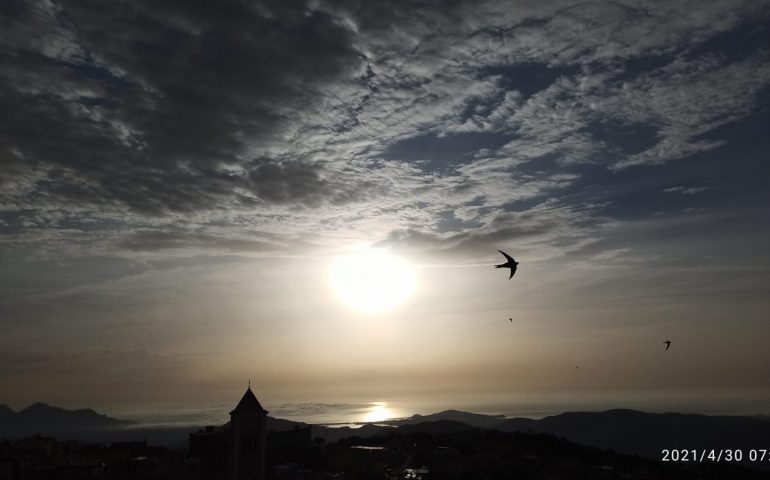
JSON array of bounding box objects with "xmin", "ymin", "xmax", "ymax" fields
[{"xmin": 495, "ymin": 410, "xmax": 770, "ymax": 459}]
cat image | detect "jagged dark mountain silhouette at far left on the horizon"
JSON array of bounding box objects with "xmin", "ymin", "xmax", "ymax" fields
[{"xmin": 0, "ymin": 403, "xmax": 134, "ymax": 438}]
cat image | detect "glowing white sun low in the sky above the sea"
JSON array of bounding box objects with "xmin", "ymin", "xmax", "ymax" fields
[{"xmin": 331, "ymin": 249, "xmax": 417, "ymax": 313}]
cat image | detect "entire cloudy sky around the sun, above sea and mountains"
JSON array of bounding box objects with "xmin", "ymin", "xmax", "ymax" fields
[{"xmin": 0, "ymin": 0, "xmax": 770, "ymax": 413}]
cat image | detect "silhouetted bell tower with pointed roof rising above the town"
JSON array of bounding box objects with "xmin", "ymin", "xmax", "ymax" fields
[{"xmin": 229, "ymin": 382, "xmax": 267, "ymax": 480}]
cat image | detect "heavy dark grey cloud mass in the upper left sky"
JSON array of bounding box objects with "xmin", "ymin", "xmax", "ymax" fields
[{"xmin": 0, "ymin": 0, "xmax": 361, "ymax": 214}]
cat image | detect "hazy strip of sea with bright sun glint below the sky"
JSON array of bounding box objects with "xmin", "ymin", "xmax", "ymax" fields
[{"xmin": 104, "ymin": 389, "xmax": 770, "ymax": 428}]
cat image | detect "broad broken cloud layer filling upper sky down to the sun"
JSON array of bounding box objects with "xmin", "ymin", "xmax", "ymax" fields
[{"xmin": 0, "ymin": 0, "xmax": 770, "ymax": 318}]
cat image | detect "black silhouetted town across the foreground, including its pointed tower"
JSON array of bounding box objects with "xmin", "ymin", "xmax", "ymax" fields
[{"xmin": 0, "ymin": 388, "xmax": 765, "ymax": 480}]
